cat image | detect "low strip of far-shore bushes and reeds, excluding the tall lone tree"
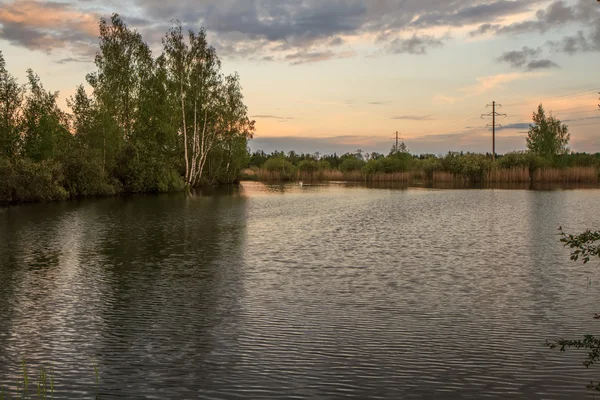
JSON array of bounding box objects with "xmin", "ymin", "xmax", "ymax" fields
[{"xmin": 247, "ymin": 151, "xmax": 600, "ymax": 182}]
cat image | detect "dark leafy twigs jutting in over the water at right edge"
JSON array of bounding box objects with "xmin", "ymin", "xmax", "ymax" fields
[{"xmin": 546, "ymin": 227, "xmax": 600, "ymax": 392}]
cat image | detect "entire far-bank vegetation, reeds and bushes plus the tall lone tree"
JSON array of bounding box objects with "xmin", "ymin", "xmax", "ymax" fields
[{"xmin": 247, "ymin": 104, "xmax": 600, "ymax": 182}]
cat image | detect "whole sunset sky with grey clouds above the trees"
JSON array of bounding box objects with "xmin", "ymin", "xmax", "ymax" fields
[{"xmin": 0, "ymin": 0, "xmax": 600, "ymax": 154}]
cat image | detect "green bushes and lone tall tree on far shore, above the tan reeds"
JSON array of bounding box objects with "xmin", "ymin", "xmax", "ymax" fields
[{"xmin": 249, "ymin": 105, "xmax": 600, "ymax": 181}]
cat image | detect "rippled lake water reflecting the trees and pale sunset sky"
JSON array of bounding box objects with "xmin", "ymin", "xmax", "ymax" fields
[{"xmin": 0, "ymin": 183, "xmax": 600, "ymax": 399}]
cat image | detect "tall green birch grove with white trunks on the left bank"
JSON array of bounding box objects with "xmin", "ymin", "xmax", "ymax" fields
[{"xmin": 0, "ymin": 14, "xmax": 254, "ymax": 202}]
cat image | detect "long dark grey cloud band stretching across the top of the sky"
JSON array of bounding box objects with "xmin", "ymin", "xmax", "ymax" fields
[{"xmin": 0, "ymin": 0, "xmax": 595, "ymax": 64}]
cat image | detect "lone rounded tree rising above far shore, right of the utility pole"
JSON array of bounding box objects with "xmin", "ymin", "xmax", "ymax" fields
[{"xmin": 527, "ymin": 104, "xmax": 571, "ymax": 158}]
